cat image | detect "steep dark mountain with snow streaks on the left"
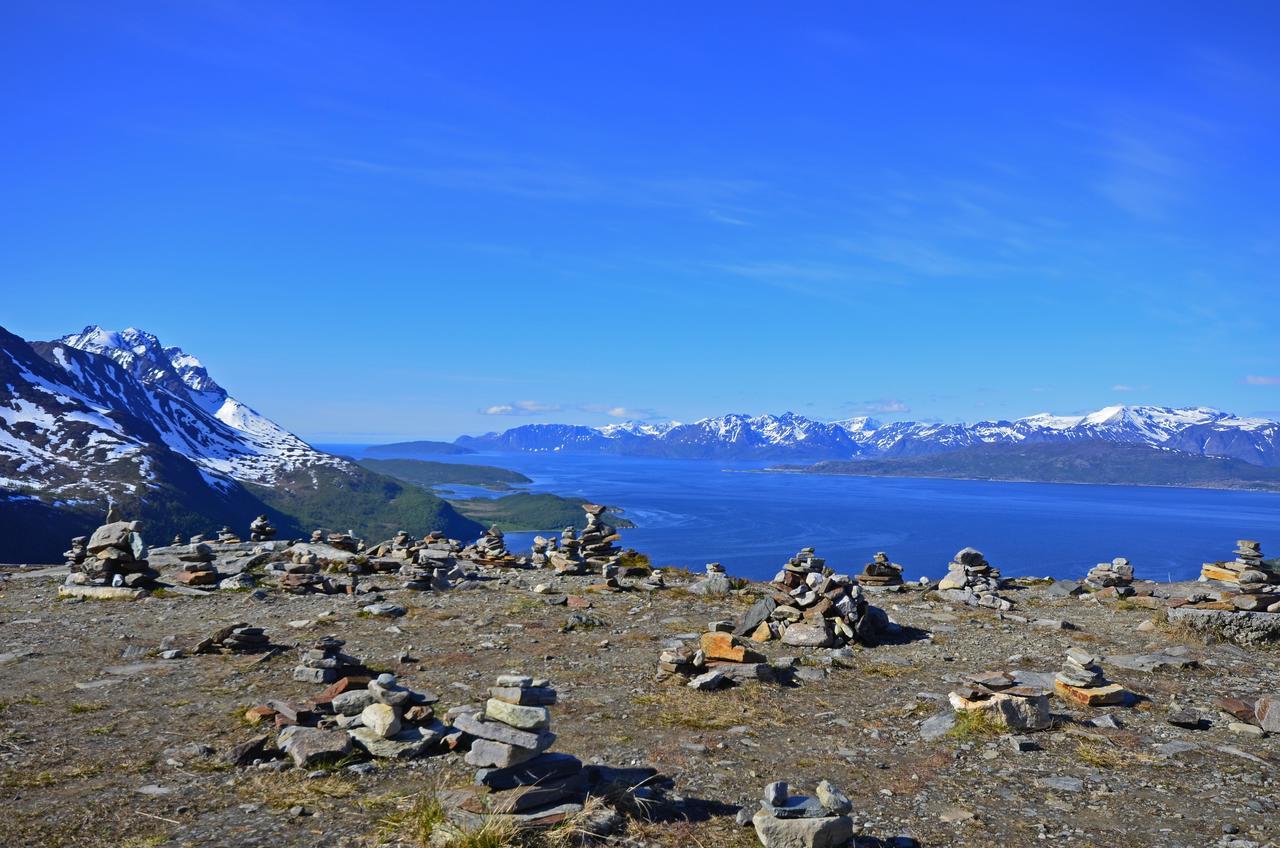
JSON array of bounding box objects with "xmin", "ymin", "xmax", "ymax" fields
[{"xmin": 0, "ymin": 327, "xmax": 481, "ymax": 562}]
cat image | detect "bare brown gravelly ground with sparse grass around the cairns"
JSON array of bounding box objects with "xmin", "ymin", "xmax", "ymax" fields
[{"xmin": 0, "ymin": 555, "xmax": 1280, "ymax": 848}]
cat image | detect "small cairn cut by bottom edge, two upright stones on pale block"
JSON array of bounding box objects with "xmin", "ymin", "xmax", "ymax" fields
[{"xmin": 751, "ymin": 780, "xmax": 854, "ymax": 848}]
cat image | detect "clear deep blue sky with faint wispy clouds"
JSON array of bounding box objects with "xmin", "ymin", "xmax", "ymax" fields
[{"xmin": 0, "ymin": 3, "xmax": 1280, "ymax": 441}]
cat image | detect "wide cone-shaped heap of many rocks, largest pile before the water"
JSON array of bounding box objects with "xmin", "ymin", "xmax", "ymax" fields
[{"xmin": 733, "ymin": 548, "xmax": 891, "ymax": 648}]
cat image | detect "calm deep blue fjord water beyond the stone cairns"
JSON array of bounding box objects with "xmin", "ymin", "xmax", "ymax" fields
[{"xmin": 317, "ymin": 446, "xmax": 1280, "ymax": 580}]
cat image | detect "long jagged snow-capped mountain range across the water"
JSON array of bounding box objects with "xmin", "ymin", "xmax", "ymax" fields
[{"xmin": 457, "ymin": 406, "xmax": 1280, "ymax": 466}]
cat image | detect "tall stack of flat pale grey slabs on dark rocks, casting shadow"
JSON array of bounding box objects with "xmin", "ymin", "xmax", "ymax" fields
[{"xmin": 449, "ymin": 675, "xmax": 586, "ymax": 828}]
